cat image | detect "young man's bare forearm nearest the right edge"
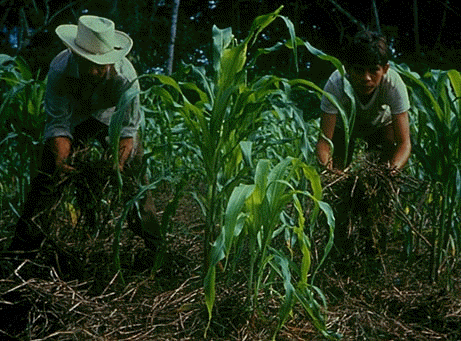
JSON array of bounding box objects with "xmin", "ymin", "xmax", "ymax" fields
[{"xmin": 389, "ymin": 112, "xmax": 411, "ymax": 170}]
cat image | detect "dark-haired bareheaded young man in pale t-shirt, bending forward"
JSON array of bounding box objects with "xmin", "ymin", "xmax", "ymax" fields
[{"xmin": 317, "ymin": 31, "xmax": 411, "ymax": 174}]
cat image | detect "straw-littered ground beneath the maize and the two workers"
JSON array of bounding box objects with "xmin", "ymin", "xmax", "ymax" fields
[{"xmin": 0, "ymin": 178, "xmax": 461, "ymax": 341}]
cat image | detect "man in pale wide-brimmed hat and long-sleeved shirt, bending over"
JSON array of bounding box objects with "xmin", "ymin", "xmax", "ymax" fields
[{"xmin": 10, "ymin": 15, "xmax": 160, "ymax": 255}]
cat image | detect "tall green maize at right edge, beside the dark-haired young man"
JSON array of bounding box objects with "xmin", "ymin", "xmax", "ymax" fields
[{"xmin": 395, "ymin": 65, "xmax": 461, "ymax": 279}]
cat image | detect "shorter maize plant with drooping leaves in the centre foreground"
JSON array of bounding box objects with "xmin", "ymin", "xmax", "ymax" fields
[{"xmin": 205, "ymin": 158, "xmax": 334, "ymax": 339}]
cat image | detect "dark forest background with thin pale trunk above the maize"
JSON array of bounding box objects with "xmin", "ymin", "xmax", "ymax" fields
[{"xmin": 0, "ymin": 0, "xmax": 461, "ymax": 80}]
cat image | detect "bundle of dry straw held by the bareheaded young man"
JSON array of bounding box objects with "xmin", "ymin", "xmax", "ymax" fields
[{"xmin": 322, "ymin": 154, "xmax": 425, "ymax": 256}]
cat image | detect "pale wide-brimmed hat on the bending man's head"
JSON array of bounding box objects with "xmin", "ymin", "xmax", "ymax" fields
[{"xmin": 56, "ymin": 15, "xmax": 133, "ymax": 65}]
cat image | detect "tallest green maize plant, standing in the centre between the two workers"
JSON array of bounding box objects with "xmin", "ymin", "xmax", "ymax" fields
[{"xmin": 142, "ymin": 6, "xmax": 295, "ymax": 268}]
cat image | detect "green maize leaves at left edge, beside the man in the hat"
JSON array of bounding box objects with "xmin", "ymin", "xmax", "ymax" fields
[{"xmin": 0, "ymin": 54, "xmax": 46, "ymax": 206}]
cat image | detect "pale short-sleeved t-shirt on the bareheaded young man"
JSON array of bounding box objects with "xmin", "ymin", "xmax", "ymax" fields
[{"xmin": 320, "ymin": 68, "xmax": 410, "ymax": 135}]
